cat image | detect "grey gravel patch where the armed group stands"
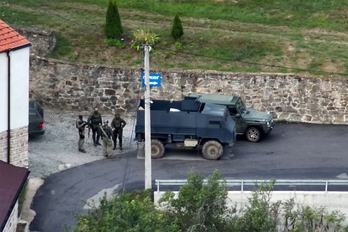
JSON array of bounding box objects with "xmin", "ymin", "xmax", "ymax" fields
[{"xmin": 29, "ymin": 110, "xmax": 137, "ymax": 178}]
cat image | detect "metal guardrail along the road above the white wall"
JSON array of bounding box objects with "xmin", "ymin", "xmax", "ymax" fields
[{"xmin": 155, "ymin": 180, "xmax": 348, "ymax": 193}]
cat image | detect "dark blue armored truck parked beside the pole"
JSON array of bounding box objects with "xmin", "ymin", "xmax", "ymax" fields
[{"xmin": 135, "ymin": 99, "xmax": 236, "ymax": 160}]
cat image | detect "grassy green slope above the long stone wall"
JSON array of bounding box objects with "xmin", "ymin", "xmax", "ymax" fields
[{"xmin": 0, "ymin": 0, "xmax": 348, "ymax": 76}]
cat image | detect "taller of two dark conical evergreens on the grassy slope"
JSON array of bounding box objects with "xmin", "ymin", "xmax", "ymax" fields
[{"xmin": 104, "ymin": 0, "xmax": 123, "ymax": 39}]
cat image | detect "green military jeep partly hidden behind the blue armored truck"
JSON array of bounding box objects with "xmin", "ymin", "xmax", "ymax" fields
[{"xmin": 186, "ymin": 93, "xmax": 274, "ymax": 143}]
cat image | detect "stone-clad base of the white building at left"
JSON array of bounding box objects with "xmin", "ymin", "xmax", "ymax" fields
[{"xmin": 0, "ymin": 126, "xmax": 29, "ymax": 168}]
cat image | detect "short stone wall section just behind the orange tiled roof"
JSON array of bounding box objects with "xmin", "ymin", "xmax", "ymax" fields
[{"xmin": 10, "ymin": 25, "xmax": 56, "ymax": 57}]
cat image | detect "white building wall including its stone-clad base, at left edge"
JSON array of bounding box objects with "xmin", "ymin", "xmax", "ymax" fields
[{"xmin": 0, "ymin": 47, "xmax": 30, "ymax": 168}]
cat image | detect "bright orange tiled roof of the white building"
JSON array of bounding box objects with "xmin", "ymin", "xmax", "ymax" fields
[{"xmin": 0, "ymin": 19, "xmax": 30, "ymax": 52}]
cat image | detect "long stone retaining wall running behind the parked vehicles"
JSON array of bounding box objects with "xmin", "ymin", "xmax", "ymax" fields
[{"xmin": 30, "ymin": 58, "xmax": 348, "ymax": 123}]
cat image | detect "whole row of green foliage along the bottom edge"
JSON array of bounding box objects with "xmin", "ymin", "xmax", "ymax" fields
[{"xmin": 70, "ymin": 171, "xmax": 348, "ymax": 232}]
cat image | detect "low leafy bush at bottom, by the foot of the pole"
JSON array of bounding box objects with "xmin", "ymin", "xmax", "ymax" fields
[{"xmin": 68, "ymin": 190, "xmax": 177, "ymax": 232}]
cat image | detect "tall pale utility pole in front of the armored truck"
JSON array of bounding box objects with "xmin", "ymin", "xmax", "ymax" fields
[{"xmin": 145, "ymin": 45, "xmax": 152, "ymax": 189}]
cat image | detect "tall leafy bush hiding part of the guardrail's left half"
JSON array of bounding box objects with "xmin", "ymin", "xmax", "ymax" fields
[{"xmin": 159, "ymin": 171, "xmax": 229, "ymax": 231}]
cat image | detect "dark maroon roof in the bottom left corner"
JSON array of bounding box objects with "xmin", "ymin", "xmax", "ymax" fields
[{"xmin": 0, "ymin": 160, "xmax": 29, "ymax": 231}]
